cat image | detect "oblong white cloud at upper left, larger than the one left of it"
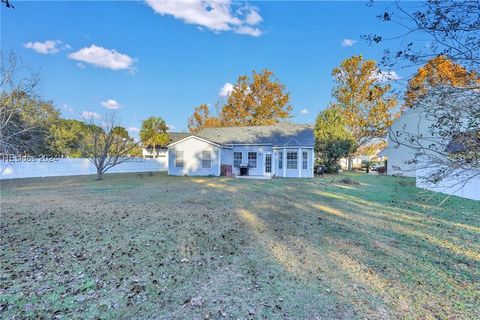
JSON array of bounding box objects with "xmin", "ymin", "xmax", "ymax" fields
[{"xmin": 68, "ymin": 45, "xmax": 135, "ymax": 70}]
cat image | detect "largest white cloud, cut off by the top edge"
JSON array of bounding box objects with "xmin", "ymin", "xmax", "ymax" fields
[{"xmin": 146, "ymin": 0, "xmax": 263, "ymax": 37}]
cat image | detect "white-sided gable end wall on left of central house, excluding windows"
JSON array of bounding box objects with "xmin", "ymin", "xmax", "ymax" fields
[{"xmin": 168, "ymin": 136, "xmax": 220, "ymax": 176}]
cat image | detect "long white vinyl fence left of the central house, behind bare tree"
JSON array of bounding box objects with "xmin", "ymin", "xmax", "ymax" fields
[{"xmin": 0, "ymin": 157, "xmax": 168, "ymax": 179}]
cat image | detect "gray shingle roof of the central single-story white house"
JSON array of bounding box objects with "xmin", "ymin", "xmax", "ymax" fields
[{"xmin": 196, "ymin": 122, "xmax": 314, "ymax": 147}]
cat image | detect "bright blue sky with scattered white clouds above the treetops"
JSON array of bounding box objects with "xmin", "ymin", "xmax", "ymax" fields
[{"xmin": 1, "ymin": 0, "xmax": 408, "ymax": 134}]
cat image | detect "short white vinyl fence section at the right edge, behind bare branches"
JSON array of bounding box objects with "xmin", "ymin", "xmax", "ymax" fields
[{"xmin": 416, "ymin": 165, "xmax": 480, "ymax": 200}]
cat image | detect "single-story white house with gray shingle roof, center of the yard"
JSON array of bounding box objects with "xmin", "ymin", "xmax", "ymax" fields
[{"xmin": 168, "ymin": 123, "xmax": 314, "ymax": 178}]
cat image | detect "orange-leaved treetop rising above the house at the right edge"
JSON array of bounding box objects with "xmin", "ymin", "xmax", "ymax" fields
[{"xmin": 405, "ymin": 55, "xmax": 480, "ymax": 108}]
